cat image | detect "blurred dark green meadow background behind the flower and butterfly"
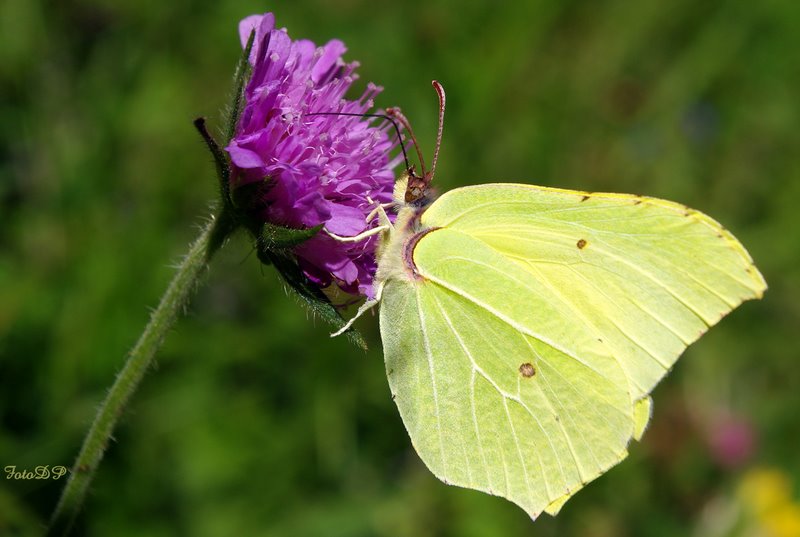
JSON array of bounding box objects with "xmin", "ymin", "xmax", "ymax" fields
[{"xmin": 0, "ymin": 0, "xmax": 800, "ymax": 537}]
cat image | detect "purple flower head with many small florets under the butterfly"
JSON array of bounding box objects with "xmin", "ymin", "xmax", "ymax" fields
[{"xmin": 226, "ymin": 13, "xmax": 398, "ymax": 297}]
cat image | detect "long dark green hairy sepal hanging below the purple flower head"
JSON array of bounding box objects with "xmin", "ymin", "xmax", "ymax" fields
[{"xmin": 258, "ymin": 248, "xmax": 367, "ymax": 350}]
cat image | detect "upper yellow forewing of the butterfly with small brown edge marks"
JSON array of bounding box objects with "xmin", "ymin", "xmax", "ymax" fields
[{"xmin": 422, "ymin": 184, "xmax": 766, "ymax": 400}]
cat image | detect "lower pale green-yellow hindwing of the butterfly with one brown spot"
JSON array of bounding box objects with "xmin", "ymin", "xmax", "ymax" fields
[{"xmin": 381, "ymin": 225, "xmax": 634, "ymax": 517}]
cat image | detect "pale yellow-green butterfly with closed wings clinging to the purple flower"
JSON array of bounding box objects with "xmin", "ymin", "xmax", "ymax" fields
[{"xmin": 330, "ymin": 81, "xmax": 767, "ymax": 519}]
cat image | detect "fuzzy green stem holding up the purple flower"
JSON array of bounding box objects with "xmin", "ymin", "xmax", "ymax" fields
[{"xmin": 47, "ymin": 214, "xmax": 234, "ymax": 536}]
